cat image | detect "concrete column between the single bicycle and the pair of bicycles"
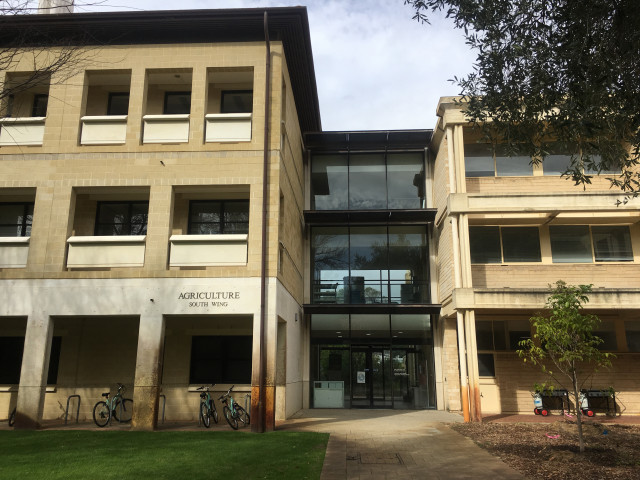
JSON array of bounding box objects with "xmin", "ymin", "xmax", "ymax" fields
[{"xmin": 132, "ymin": 314, "xmax": 165, "ymax": 430}]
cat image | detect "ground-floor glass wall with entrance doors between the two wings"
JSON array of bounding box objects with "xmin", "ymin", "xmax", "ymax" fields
[{"xmin": 311, "ymin": 314, "xmax": 436, "ymax": 409}]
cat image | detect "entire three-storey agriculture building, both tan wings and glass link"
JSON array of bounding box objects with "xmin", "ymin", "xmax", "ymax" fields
[{"xmin": 0, "ymin": 7, "xmax": 640, "ymax": 431}]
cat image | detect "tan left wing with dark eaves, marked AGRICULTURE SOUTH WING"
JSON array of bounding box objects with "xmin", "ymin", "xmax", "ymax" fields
[{"xmin": 0, "ymin": 8, "xmax": 321, "ymax": 429}]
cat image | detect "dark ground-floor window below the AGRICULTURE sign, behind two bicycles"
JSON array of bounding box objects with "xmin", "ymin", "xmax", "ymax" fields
[{"xmin": 189, "ymin": 335, "xmax": 253, "ymax": 384}]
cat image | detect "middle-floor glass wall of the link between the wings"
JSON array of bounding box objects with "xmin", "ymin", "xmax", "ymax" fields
[{"xmin": 311, "ymin": 226, "xmax": 429, "ymax": 304}]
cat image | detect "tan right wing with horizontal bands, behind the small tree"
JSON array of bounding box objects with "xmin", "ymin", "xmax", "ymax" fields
[{"xmin": 431, "ymin": 97, "xmax": 640, "ymax": 419}]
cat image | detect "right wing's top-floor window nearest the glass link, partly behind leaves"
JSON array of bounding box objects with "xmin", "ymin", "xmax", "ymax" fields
[{"xmin": 464, "ymin": 143, "xmax": 533, "ymax": 177}]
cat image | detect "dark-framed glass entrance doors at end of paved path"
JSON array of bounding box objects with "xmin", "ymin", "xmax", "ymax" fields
[{"xmin": 351, "ymin": 346, "xmax": 393, "ymax": 408}]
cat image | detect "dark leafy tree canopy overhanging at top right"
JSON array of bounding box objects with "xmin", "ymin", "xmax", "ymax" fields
[{"xmin": 405, "ymin": 0, "xmax": 640, "ymax": 200}]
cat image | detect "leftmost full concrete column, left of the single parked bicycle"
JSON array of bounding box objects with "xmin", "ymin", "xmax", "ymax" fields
[{"xmin": 15, "ymin": 313, "xmax": 53, "ymax": 429}]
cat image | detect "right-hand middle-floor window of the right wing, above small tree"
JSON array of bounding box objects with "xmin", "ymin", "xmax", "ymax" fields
[{"xmin": 549, "ymin": 225, "xmax": 633, "ymax": 263}]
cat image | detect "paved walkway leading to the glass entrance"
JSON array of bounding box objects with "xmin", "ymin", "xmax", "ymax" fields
[{"xmin": 278, "ymin": 409, "xmax": 524, "ymax": 480}]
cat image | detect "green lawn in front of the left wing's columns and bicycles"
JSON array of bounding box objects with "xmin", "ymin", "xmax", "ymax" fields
[{"xmin": 0, "ymin": 431, "xmax": 329, "ymax": 480}]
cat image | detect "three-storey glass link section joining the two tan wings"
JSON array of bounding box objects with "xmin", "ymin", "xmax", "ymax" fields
[{"xmin": 304, "ymin": 130, "xmax": 442, "ymax": 409}]
